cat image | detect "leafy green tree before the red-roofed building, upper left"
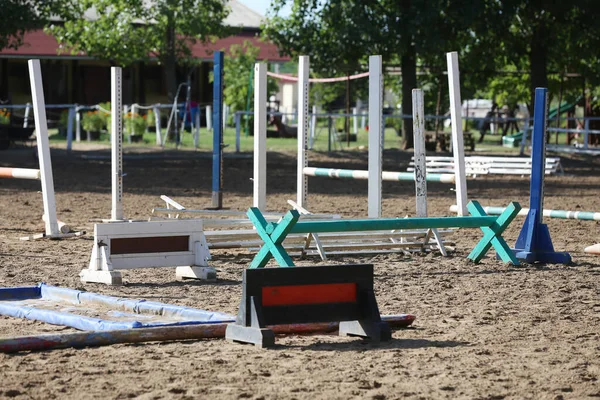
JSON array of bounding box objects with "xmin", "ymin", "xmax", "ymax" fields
[{"xmin": 48, "ymin": 0, "xmax": 230, "ymax": 100}]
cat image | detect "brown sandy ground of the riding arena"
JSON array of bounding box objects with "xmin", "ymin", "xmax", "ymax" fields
[{"xmin": 0, "ymin": 148, "xmax": 600, "ymax": 399}]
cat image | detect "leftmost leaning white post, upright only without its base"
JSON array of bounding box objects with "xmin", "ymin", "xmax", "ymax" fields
[{"xmin": 29, "ymin": 60, "xmax": 60, "ymax": 236}]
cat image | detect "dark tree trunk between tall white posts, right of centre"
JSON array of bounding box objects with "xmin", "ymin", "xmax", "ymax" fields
[{"xmin": 401, "ymin": 45, "xmax": 417, "ymax": 150}]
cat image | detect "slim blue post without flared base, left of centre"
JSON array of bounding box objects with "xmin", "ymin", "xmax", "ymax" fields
[{"xmin": 212, "ymin": 51, "xmax": 223, "ymax": 209}]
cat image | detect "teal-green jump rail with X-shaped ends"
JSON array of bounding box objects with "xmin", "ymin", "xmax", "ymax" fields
[{"xmin": 247, "ymin": 201, "xmax": 521, "ymax": 268}]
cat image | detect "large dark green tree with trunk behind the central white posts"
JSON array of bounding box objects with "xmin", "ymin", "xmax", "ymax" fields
[{"xmin": 264, "ymin": 0, "xmax": 492, "ymax": 148}]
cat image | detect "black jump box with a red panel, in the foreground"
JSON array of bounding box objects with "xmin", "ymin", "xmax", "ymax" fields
[{"xmin": 225, "ymin": 264, "xmax": 391, "ymax": 348}]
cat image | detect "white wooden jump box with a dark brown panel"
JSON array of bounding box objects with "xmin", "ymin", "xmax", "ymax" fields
[{"xmin": 79, "ymin": 220, "xmax": 217, "ymax": 285}]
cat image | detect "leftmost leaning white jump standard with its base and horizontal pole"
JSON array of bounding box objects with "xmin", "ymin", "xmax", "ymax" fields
[{"xmin": 0, "ymin": 60, "xmax": 80, "ymax": 240}]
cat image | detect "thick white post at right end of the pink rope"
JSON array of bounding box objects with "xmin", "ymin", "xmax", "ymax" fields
[{"xmin": 368, "ymin": 56, "xmax": 383, "ymax": 218}]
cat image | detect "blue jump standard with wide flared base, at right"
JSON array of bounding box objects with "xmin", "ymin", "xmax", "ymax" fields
[{"xmin": 514, "ymin": 88, "xmax": 571, "ymax": 264}]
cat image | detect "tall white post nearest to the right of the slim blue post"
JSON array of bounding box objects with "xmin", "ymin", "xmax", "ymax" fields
[{"xmin": 252, "ymin": 63, "xmax": 267, "ymax": 212}]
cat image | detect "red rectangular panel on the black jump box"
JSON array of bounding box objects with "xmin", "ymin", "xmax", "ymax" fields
[{"xmin": 262, "ymin": 283, "xmax": 356, "ymax": 307}]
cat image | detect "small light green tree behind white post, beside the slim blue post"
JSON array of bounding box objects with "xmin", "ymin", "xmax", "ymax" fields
[{"xmin": 221, "ymin": 41, "xmax": 277, "ymax": 115}]
